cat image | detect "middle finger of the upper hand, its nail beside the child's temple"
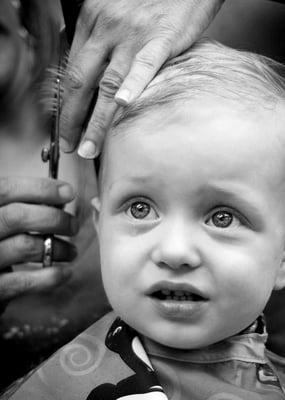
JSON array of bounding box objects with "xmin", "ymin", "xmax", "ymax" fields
[{"xmin": 78, "ymin": 47, "xmax": 132, "ymax": 159}]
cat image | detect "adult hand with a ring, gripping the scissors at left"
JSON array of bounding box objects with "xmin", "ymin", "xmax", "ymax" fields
[{"xmin": 0, "ymin": 177, "xmax": 78, "ymax": 305}]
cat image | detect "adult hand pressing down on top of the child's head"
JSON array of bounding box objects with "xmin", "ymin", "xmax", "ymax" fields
[{"xmin": 61, "ymin": 0, "xmax": 224, "ymax": 158}]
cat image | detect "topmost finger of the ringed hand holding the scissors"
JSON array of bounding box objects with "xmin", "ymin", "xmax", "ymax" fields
[{"xmin": 0, "ymin": 177, "xmax": 75, "ymax": 206}]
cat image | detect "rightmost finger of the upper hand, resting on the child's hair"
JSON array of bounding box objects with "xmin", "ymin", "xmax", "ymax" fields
[{"xmin": 115, "ymin": 38, "xmax": 170, "ymax": 105}]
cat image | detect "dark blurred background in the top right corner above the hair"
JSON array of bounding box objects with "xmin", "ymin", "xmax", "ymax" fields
[{"xmin": 206, "ymin": 0, "xmax": 285, "ymax": 61}]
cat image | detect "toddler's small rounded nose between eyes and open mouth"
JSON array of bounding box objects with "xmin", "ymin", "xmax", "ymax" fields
[{"xmin": 152, "ymin": 223, "xmax": 202, "ymax": 269}]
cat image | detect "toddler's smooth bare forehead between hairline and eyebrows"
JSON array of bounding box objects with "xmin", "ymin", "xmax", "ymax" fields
[{"xmin": 104, "ymin": 99, "xmax": 285, "ymax": 188}]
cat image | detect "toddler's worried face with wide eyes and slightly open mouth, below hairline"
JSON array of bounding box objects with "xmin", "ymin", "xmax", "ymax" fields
[{"xmin": 94, "ymin": 101, "xmax": 285, "ymax": 349}]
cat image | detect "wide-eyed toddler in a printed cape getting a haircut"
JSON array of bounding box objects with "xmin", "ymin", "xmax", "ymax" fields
[{"xmin": 7, "ymin": 41, "xmax": 285, "ymax": 400}]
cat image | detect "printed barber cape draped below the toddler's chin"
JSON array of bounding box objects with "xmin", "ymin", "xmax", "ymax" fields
[{"xmin": 3, "ymin": 313, "xmax": 285, "ymax": 400}]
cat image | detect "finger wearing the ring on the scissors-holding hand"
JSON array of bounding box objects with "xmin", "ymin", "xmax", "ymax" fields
[{"xmin": 0, "ymin": 234, "xmax": 77, "ymax": 269}]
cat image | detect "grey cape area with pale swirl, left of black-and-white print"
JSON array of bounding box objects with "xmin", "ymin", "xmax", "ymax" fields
[{"xmin": 3, "ymin": 312, "xmax": 116, "ymax": 400}]
